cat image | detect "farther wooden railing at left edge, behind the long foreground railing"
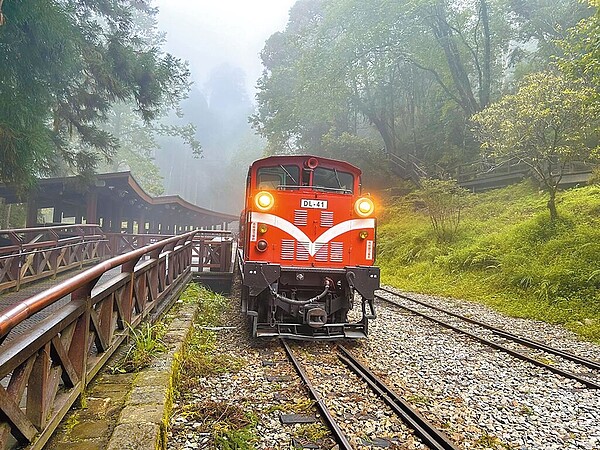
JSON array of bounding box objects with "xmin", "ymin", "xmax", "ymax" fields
[{"xmin": 0, "ymin": 225, "xmax": 108, "ymax": 292}]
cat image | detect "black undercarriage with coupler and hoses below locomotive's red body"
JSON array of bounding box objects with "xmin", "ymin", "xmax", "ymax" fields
[{"xmin": 242, "ymin": 262, "xmax": 379, "ymax": 340}]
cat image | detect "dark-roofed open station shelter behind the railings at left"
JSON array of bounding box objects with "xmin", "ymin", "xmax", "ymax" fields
[{"xmin": 0, "ymin": 172, "xmax": 238, "ymax": 230}]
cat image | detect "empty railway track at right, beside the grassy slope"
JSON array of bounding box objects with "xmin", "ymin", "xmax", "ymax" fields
[{"xmin": 376, "ymin": 288, "xmax": 600, "ymax": 389}]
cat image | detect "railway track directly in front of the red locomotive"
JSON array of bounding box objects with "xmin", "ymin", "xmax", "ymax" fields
[{"xmin": 282, "ymin": 340, "xmax": 457, "ymax": 450}]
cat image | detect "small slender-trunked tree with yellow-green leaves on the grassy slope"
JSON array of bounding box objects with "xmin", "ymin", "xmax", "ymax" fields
[{"xmin": 473, "ymin": 72, "xmax": 600, "ymax": 220}]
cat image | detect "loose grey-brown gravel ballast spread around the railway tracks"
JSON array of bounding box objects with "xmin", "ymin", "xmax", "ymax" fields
[{"xmin": 168, "ymin": 288, "xmax": 600, "ymax": 450}]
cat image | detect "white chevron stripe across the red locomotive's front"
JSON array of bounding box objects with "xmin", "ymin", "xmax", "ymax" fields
[{"xmin": 250, "ymin": 211, "xmax": 375, "ymax": 256}]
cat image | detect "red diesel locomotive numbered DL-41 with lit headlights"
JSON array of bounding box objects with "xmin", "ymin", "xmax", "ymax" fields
[{"xmin": 240, "ymin": 156, "xmax": 379, "ymax": 339}]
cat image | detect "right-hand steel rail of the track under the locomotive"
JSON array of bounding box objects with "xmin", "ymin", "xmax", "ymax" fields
[{"xmin": 338, "ymin": 345, "xmax": 458, "ymax": 450}]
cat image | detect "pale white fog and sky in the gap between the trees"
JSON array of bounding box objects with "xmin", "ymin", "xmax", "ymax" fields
[{"xmin": 155, "ymin": 0, "xmax": 295, "ymax": 214}]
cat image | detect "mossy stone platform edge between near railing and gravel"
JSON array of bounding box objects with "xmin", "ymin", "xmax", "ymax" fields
[{"xmin": 107, "ymin": 304, "xmax": 198, "ymax": 450}]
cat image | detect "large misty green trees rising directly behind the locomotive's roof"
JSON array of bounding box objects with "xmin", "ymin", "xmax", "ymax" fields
[{"xmin": 252, "ymin": 0, "xmax": 590, "ymax": 181}]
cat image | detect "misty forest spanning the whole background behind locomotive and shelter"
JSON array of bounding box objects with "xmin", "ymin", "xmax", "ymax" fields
[{"xmin": 0, "ymin": 0, "xmax": 600, "ymax": 213}]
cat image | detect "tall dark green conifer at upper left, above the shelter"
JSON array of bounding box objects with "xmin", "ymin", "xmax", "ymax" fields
[{"xmin": 0, "ymin": 0, "xmax": 189, "ymax": 190}]
